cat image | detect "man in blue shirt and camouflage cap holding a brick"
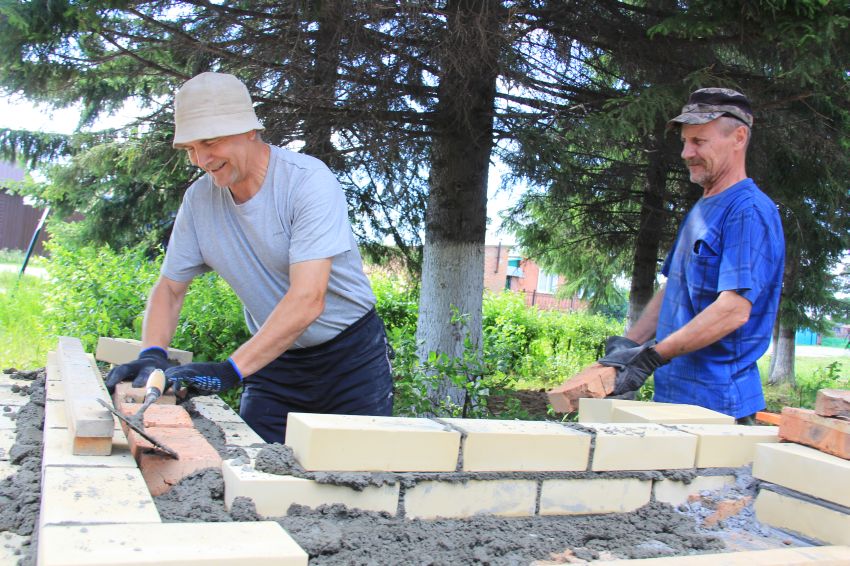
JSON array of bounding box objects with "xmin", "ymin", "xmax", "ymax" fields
[{"xmin": 599, "ymin": 88, "xmax": 785, "ymax": 421}]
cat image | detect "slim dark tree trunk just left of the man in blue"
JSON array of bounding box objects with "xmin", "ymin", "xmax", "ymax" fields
[{"xmin": 628, "ymin": 131, "xmax": 667, "ymax": 326}]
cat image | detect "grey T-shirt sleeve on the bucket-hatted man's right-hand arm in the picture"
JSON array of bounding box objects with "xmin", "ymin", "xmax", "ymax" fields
[{"xmin": 289, "ymin": 169, "xmax": 352, "ymax": 264}]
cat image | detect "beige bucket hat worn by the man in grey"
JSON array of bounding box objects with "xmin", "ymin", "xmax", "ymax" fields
[{"xmin": 172, "ymin": 73, "xmax": 264, "ymax": 145}]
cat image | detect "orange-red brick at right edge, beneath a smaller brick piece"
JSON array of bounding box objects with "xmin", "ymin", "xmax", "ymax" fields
[{"xmin": 779, "ymin": 407, "xmax": 850, "ymax": 460}]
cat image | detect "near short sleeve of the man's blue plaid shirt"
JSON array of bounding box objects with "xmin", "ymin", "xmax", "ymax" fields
[{"xmin": 717, "ymin": 206, "xmax": 775, "ymax": 303}]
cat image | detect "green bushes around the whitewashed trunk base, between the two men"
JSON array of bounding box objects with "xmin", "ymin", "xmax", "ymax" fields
[{"xmin": 388, "ymin": 292, "xmax": 620, "ymax": 419}]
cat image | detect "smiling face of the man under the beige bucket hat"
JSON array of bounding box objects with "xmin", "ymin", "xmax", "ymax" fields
[{"xmin": 175, "ymin": 131, "xmax": 257, "ymax": 189}]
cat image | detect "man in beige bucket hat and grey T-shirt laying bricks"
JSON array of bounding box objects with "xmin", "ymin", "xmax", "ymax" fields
[{"xmin": 107, "ymin": 73, "xmax": 392, "ymax": 443}]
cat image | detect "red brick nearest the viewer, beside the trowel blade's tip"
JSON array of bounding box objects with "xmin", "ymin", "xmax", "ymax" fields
[{"xmin": 131, "ymin": 427, "xmax": 221, "ymax": 496}]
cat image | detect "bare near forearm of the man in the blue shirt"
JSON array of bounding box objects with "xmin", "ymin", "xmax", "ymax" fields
[{"xmin": 655, "ymin": 291, "xmax": 752, "ymax": 360}]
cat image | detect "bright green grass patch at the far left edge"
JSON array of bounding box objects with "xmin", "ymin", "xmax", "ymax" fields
[{"xmin": 0, "ymin": 271, "xmax": 56, "ymax": 369}]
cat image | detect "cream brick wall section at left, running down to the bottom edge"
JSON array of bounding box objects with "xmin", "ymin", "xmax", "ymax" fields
[{"xmin": 38, "ymin": 338, "xmax": 307, "ymax": 566}]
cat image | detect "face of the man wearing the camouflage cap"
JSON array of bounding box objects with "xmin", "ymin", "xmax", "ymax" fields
[{"xmin": 681, "ymin": 118, "xmax": 749, "ymax": 196}]
